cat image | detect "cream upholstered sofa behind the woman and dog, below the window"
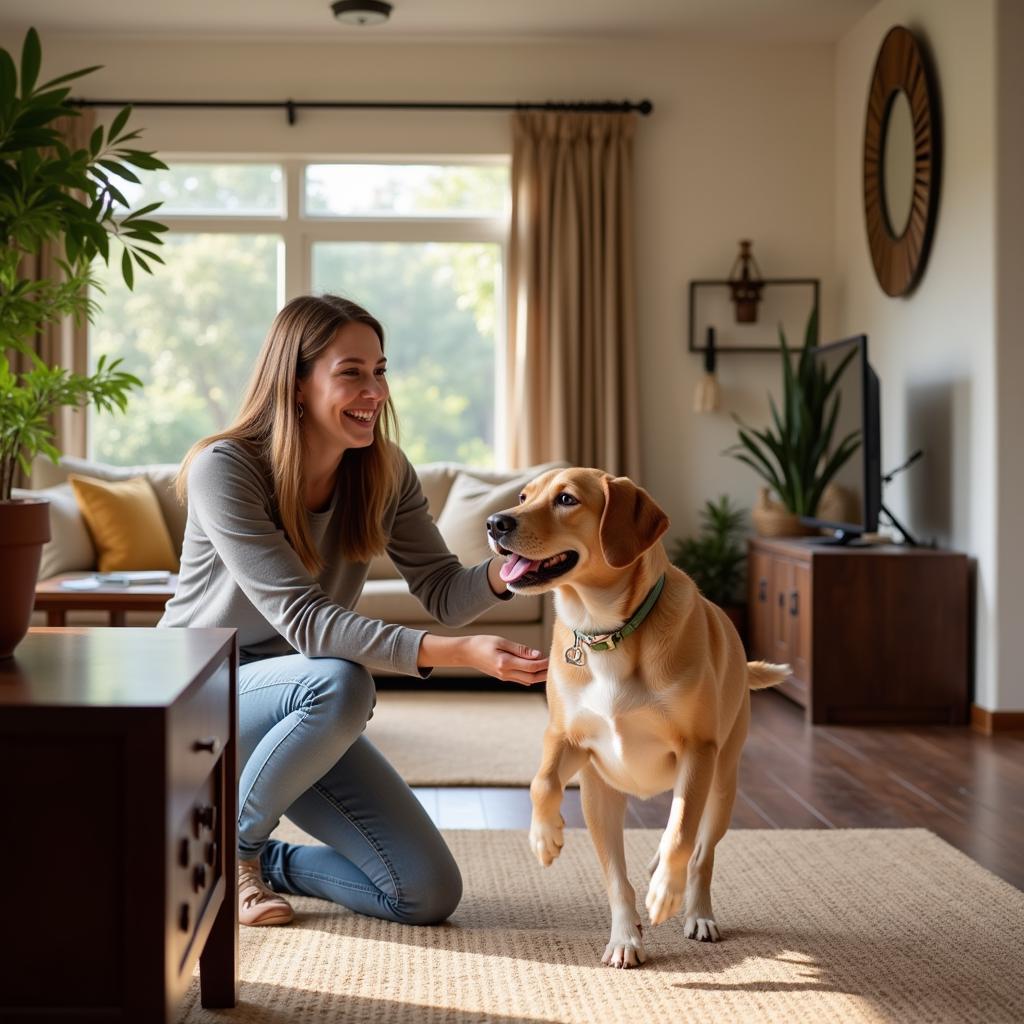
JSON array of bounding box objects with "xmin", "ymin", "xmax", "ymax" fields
[{"xmin": 14, "ymin": 456, "xmax": 565, "ymax": 675}]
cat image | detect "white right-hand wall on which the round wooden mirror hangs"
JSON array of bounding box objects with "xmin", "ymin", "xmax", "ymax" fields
[{"xmin": 836, "ymin": 0, "xmax": 1024, "ymax": 710}]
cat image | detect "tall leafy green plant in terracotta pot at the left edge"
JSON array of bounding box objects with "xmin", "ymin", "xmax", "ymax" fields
[{"xmin": 0, "ymin": 29, "xmax": 166, "ymax": 657}]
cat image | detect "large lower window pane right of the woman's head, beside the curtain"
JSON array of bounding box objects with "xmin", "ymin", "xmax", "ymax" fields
[{"xmin": 313, "ymin": 242, "xmax": 501, "ymax": 466}]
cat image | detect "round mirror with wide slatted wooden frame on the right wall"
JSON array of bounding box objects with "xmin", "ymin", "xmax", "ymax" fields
[{"xmin": 864, "ymin": 26, "xmax": 940, "ymax": 296}]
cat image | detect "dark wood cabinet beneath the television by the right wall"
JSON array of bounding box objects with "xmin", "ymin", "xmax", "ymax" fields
[{"xmin": 748, "ymin": 538, "xmax": 970, "ymax": 725}]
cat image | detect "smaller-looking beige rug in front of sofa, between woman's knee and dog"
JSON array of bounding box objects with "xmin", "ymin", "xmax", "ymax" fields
[{"xmin": 367, "ymin": 690, "xmax": 578, "ymax": 785}]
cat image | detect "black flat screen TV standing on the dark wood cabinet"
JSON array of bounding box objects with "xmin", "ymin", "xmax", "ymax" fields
[{"xmin": 801, "ymin": 334, "xmax": 882, "ymax": 544}]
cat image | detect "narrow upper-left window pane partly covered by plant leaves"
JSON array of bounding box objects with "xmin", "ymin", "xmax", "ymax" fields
[{"xmin": 118, "ymin": 164, "xmax": 285, "ymax": 219}]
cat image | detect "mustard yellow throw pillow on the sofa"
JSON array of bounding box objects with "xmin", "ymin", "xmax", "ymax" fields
[{"xmin": 68, "ymin": 473, "xmax": 178, "ymax": 572}]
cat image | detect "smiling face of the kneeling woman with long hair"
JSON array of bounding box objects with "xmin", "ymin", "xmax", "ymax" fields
[{"xmin": 297, "ymin": 323, "xmax": 389, "ymax": 455}]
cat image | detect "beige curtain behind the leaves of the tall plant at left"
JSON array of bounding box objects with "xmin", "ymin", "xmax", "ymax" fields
[{"xmin": 9, "ymin": 108, "xmax": 96, "ymax": 486}]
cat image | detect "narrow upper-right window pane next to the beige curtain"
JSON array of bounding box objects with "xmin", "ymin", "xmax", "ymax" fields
[{"xmin": 305, "ymin": 164, "xmax": 509, "ymax": 217}]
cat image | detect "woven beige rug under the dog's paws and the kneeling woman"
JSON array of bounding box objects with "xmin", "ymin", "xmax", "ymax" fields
[{"xmin": 181, "ymin": 829, "xmax": 1024, "ymax": 1024}]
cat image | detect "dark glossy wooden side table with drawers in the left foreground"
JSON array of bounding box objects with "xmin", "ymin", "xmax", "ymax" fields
[{"xmin": 0, "ymin": 628, "xmax": 238, "ymax": 1024}]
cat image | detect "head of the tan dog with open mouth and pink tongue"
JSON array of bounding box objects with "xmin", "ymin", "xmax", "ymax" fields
[{"xmin": 487, "ymin": 469, "xmax": 669, "ymax": 593}]
